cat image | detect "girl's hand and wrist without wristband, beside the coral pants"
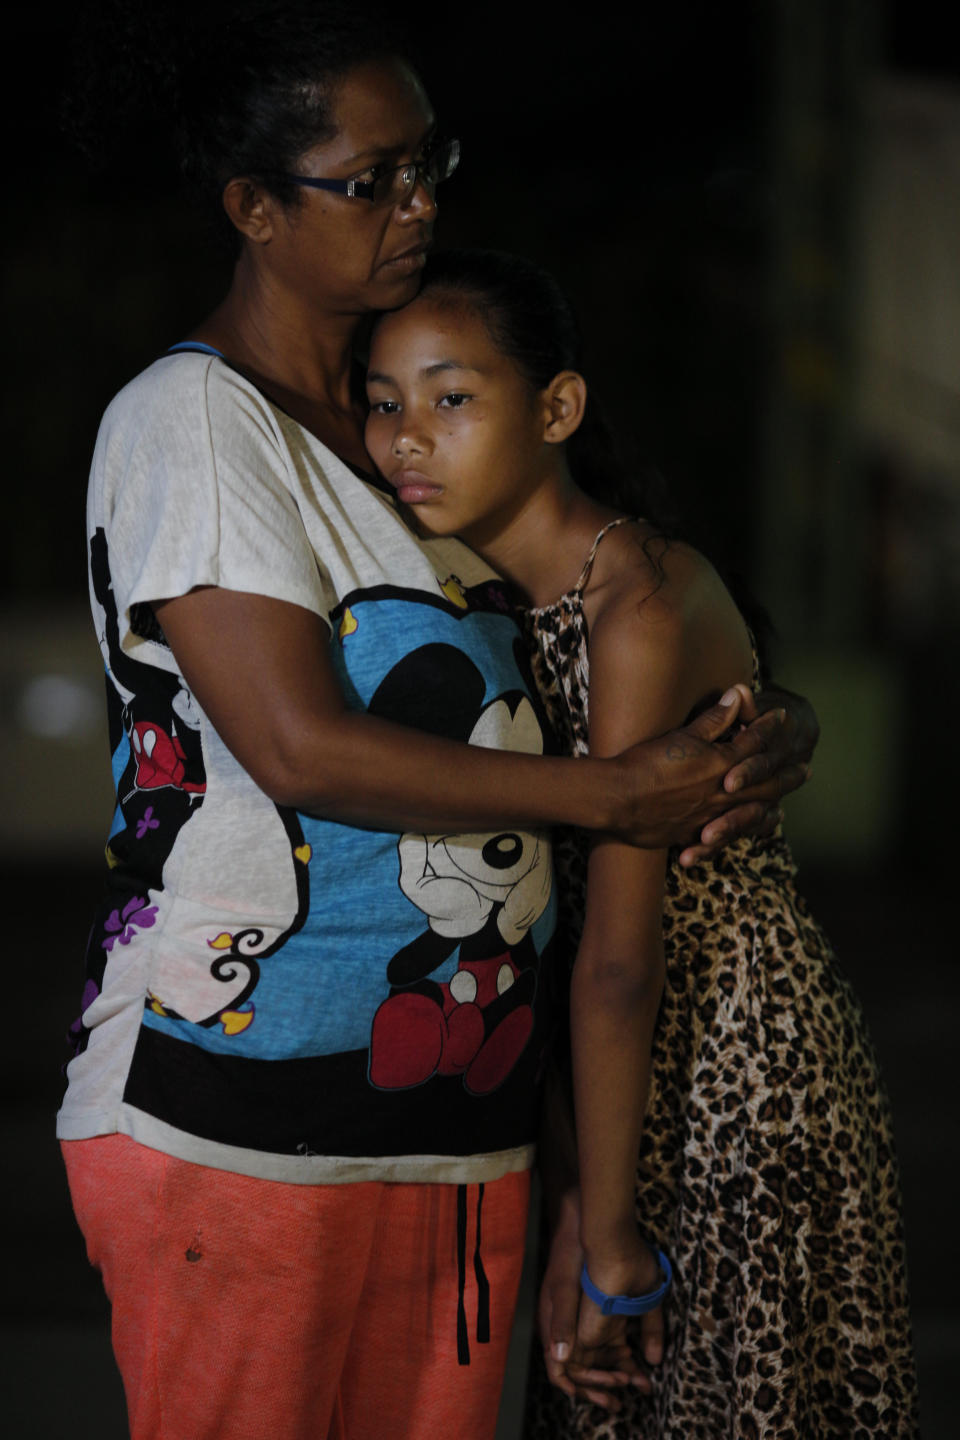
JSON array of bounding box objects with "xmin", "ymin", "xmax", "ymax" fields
[{"xmin": 537, "ymin": 1192, "xmax": 656, "ymax": 1413}]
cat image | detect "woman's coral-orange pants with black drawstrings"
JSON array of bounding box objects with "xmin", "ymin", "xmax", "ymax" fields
[{"xmin": 62, "ymin": 1135, "xmax": 530, "ymax": 1440}]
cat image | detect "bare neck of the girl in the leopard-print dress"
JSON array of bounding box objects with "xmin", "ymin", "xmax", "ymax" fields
[{"xmin": 462, "ymin": 467, "xmax": 619, "ymax": 606}]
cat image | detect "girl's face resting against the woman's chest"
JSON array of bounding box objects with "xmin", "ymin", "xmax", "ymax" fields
[{"xmin": 366, "ymin": 294, "xmax": 556, "ymax": 549}]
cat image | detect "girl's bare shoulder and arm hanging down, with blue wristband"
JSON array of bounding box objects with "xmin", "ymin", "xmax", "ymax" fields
[{"xmin": 570, "ymin": 552, "xmax": 751, "ymax": 1374}]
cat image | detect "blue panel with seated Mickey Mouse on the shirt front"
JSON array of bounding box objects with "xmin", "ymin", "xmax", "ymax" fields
[{"xmin": 145, "ymin": 585, "xmax": 554, "ymax": 1094}]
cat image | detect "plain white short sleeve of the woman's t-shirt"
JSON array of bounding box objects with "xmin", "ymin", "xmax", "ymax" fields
[{"xmin": 91, "ymin": 354, "xmax": 335, "ymax": 662}]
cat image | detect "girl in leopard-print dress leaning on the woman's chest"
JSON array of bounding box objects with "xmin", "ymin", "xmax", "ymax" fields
[{"xmin": 366, "ymin": 252, "xmax": 915, "ymax": 1440}]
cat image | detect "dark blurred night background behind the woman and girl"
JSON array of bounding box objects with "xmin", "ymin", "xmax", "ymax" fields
[{"xmin": 0, "ymin": 0, "xmax": 960, "ymax": 1440}]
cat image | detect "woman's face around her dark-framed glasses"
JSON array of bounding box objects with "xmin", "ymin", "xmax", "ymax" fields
[{"xmin": 271, "ymin": 59, "xmax": 436, "ymax": 315}]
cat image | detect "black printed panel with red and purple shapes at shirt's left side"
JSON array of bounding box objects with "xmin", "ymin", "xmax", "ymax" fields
[{"xmin": 71, "ymin": 530, "xmax": 206, "ymax": 1050}]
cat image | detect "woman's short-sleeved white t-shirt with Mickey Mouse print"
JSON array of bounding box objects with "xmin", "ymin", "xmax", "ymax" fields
[{"xmin": 58, "ymin": 353, "xmax": 554, "ymax": 1184}]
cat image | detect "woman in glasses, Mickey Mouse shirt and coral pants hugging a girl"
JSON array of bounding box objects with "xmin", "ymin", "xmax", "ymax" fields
[{"xmin": 59, "ymin": 6, "xmax": 802, "ymax": 1440}]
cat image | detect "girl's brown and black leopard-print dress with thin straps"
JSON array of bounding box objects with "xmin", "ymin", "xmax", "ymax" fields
[{"xmin": 524, "ymin": 521, "xmax": 917, "ymax": 1440}]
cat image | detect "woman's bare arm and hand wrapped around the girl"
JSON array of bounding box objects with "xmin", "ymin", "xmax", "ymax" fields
[{"xmin": 154, "ymin": 586, "xmax": 802, "ymax": 845}]
